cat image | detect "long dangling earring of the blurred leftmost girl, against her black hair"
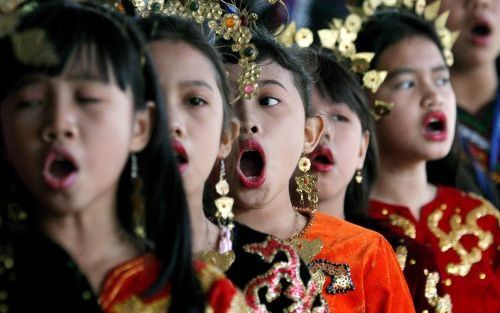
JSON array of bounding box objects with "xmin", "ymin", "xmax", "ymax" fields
[{"xmin": 130, "ymin": 154, "xmax": 146, "ymax": 239}]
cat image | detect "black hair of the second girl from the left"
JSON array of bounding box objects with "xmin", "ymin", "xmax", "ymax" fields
[{"xmin": 139, "ymin": 15, "xmax": 232, "ymax": 127}]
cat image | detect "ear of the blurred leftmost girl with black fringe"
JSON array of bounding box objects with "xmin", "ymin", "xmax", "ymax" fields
[{"xmin": 129, "ymin": 101, "xmax": 156, "ymax": 152}]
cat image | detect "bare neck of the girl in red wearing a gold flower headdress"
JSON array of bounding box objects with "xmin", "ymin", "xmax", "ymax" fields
[{"xmin": 370, "ymin": 157, "xmax": 436, "ymax": 219}]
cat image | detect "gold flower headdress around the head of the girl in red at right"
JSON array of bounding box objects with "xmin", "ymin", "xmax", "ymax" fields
[{"xmin": 278, "ymin": 0, "xmax": 458, "ymax": 120}]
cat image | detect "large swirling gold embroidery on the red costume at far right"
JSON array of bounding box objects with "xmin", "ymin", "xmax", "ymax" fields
[{"xmin": 427, "ymin": 201, "xmax": 500, "ymax": 277}]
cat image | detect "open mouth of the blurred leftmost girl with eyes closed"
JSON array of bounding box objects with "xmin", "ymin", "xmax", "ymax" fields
[{"xmin": 42, "ymin": 149, "xmax": 78, "ymax": 191}]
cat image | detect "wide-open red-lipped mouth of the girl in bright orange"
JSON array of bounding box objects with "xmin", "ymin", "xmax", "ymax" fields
[{"xmin": 237, "ymin": 140, "xmax": 266, "ymax": 188}]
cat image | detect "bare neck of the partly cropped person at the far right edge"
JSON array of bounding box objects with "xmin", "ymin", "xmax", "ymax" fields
[{"xmin": 451, "ymin": 63, "xmax": 498, "ymax": 114}]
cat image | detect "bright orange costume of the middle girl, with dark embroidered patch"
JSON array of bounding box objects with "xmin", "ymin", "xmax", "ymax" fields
[{"xmin": 290, "ymin": 212, "xmax": 415, "ymax": 313}]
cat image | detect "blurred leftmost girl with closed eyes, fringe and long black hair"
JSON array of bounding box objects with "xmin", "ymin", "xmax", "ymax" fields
[{"xmin": 0, "ymin": 1, "xmax": 240, "ymax": 312}]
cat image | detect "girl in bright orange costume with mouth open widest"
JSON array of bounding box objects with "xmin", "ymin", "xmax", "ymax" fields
[{"xmin": 226, "ymin": 27, "xmax": 414, "ymax": 312}]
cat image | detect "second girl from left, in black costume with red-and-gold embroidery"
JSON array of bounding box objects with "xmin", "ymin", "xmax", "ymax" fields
[{"xmin": 141, "ymin": 15, "xmax": 325, "ymax": 312}]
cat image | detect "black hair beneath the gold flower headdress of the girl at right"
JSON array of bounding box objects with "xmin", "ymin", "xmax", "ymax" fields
[{"xmin": 355, "ymin": 9, "xmax": 444, "ymax": 68}]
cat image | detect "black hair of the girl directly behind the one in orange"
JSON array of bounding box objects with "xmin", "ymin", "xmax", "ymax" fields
[{"xmin": 304, "ymin": 48, "xmax": 378, "ymax": 221}]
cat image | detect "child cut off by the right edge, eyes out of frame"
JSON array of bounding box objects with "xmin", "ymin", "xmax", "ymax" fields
[{"xmin": 442, "ymin": 0, "xmax": 500, "ymax": 207}]
